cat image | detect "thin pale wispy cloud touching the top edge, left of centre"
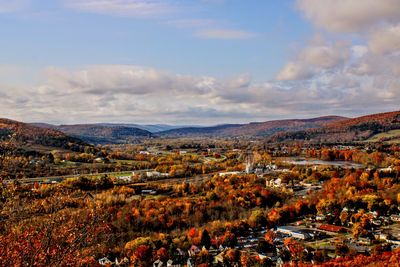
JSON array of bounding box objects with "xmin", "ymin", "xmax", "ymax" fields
[{"xmin": 64, "ymin": 0, "xmax": 176, "ymax": 17}]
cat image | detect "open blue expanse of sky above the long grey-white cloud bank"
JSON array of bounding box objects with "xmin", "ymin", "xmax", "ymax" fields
[{"xmin": 0, "ymin": 0, "xmax": 311, "ymax": 80}]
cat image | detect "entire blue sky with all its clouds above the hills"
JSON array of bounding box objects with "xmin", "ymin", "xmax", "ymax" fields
[{"xmin": 0, "ymin": 0, "xmax": 400, "ymax": 125}]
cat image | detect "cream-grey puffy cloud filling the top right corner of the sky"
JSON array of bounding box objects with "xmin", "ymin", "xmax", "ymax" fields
[{"xmin": 297, "ymin": 0, "xmax": 400, "ymax": 32}]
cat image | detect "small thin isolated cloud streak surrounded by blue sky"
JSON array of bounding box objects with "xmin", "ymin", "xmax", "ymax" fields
[{"xmin": 194, "ymin": 28, "xmax": 256, "ymax": 40}]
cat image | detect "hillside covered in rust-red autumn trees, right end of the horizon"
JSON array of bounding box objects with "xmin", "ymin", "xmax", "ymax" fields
[{"xmin": 269, "ymin": 111, "xmax": 400, "ymax": 143}]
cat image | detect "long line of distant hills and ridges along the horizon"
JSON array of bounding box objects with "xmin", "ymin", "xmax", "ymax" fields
[{"xmin": 22, "ymin": 111, "xmax": 400, "ymax": 144}]
